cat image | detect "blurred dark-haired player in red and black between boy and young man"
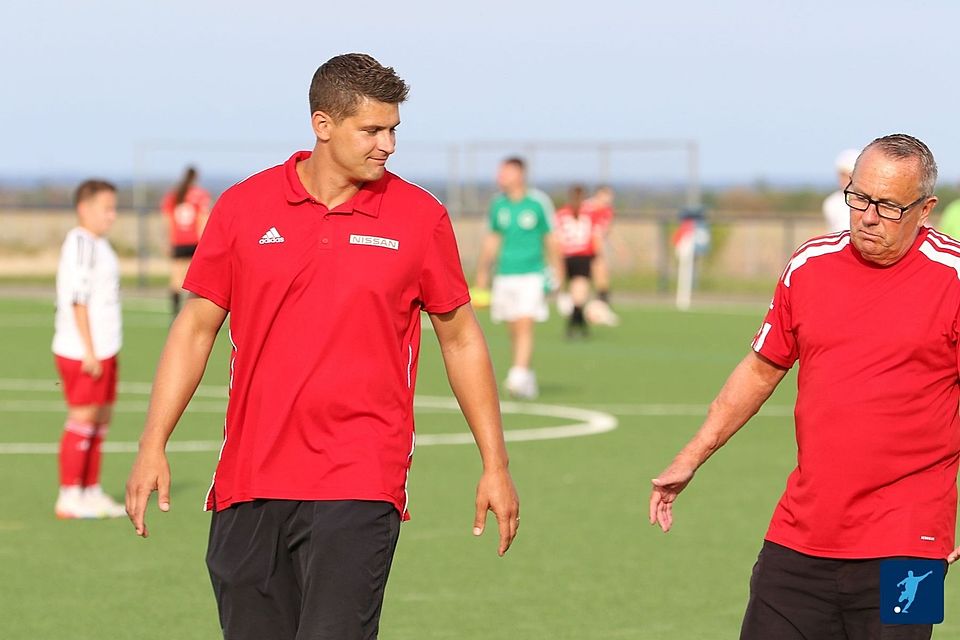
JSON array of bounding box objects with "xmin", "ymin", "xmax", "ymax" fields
[{"xmin": 160, "ymin": 167, "xmax": 210, "ymax": 316}]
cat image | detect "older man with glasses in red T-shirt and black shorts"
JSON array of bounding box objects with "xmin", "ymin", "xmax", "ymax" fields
[{"xmin": 650, "ymin": 134, "xmax": 960, "ymax": 640}]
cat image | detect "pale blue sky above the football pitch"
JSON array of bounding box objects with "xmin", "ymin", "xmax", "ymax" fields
[{"xmin": 0, "ymin": 0, "xmax": 960, "ymax": 184}]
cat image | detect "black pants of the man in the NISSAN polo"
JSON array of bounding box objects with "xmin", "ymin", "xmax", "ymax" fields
[{"xmin": 207, "ymin": 500, "xmax": 400, "ymax": 640}]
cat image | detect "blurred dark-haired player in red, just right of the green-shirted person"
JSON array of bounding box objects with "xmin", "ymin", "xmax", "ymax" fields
[{"xmin": 556, "ymin": 185, "xmax": 602, "ymax": 338}]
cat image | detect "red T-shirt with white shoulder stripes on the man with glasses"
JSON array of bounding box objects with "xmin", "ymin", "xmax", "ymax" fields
[{"xmin": 753, "ymin": 229, "xmax": 960, "ymax": 558}]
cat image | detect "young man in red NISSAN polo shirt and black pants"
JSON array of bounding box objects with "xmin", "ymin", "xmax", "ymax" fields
[{"xmin": 127, "ymin": 54, "xmax": 519, "ymax": 640}]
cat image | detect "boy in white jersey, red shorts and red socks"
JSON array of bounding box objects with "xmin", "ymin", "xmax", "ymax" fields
[{"xmin": 52, "ymin": 180, "xmax": 126, "ymax": 518}]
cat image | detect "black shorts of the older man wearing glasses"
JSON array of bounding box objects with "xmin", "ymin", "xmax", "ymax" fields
[{"xmin": 740, "ymin": 540, "xmax": 933, "ymax": 640}]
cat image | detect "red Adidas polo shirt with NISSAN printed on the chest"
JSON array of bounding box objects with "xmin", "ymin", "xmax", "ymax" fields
[{"xmin": 184, "ymin": 151, "xmax": 469, "ymax": 518}]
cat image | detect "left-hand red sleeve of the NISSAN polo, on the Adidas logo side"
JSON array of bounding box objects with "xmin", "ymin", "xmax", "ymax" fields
[{"xmin": 183, "ymin": 192, "xmax": 233, "ymax": 311}]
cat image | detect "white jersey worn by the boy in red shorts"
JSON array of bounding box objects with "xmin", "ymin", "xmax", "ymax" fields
[{"xmin": 53, "ymin": 227, "xmax": 122, "ymax": 360}]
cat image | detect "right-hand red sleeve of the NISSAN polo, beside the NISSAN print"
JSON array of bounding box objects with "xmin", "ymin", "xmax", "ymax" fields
[{"xmin": 420, "ymin": 210, "xmax": 470, "ymax": 313}]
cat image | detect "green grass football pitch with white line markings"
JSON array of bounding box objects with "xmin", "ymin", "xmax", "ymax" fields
[{"xmin": 0, "ymin": 297, "xmax": 960, "ymax": 640}]
